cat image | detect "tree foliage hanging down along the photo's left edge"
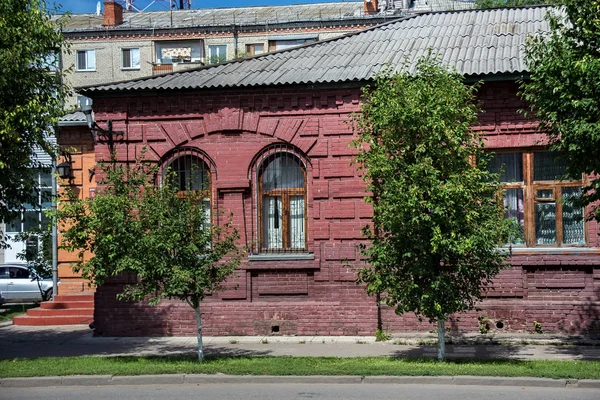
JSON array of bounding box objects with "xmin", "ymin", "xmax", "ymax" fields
[{"xmin": 0, "ymin": 0, "xmax": 68, "ymax": 246}]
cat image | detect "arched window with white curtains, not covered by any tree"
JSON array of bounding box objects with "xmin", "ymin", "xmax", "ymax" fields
[{"xmin": 258, "ymin": 151, "xmax": 306, "ymax": 252}]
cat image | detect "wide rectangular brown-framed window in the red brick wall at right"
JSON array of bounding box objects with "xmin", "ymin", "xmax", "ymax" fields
[{"xmin": 489, "ymin": 151, "xmax": 586, "ymax": 246}]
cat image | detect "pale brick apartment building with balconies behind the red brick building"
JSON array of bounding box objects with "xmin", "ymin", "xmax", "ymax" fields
[{"xmin": 62, "ymin": 0, "xmax": 473, "ymax": 105}]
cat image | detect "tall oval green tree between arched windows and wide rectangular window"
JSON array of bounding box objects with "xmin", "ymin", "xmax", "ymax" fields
[{"xmin": 355, "ymin": 57, "xmax": 506, "ymax": 360}]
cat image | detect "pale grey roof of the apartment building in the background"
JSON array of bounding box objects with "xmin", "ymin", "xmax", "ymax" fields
[{"xmin": 58, "ymin": 0, "xmax": 473, "ymax": 32}]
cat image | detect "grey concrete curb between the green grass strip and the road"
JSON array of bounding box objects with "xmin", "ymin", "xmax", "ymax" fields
[{"xmin": 0, "ymin": 374, "xmax": 600, "ymax": 389}]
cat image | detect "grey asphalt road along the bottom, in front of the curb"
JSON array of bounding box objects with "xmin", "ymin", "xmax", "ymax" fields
[{"xmin": 0, "ymin": 383, "xmax": 600, "ymax": 400}]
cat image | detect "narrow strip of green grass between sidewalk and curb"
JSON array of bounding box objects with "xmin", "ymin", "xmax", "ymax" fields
[{"xmin": 0, "ymin": 356, "xmax": 600, "ymax": 379}]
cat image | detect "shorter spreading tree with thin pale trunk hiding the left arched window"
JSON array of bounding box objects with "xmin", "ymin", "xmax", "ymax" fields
[{"xmin": 58, "ymin": 160, "xmax": 242, "ymax": 361}]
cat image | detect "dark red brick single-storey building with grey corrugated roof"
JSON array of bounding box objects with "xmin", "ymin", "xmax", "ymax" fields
[{"xmin": 59, "ymin": 7, "xmax": 600, "ymax": 336}]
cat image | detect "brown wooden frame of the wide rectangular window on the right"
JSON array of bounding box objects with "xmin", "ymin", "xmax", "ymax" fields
[{"xmin": 495, "ymin": 149, "xmax": 589, "ymax": 247}]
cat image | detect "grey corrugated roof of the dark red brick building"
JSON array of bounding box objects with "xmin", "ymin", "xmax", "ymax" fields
[{"xmin": 80, "ymin": 7, "xmax": 551, "ymax": 94}]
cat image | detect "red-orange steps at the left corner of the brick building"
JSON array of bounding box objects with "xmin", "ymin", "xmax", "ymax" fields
[{"xmin": 13, "ymin": 292, "xmax": 94, "ymax": 326}]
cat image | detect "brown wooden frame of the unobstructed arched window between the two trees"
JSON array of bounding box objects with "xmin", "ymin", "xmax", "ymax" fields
[{"xmin": 257, "ymin": 148, "xmax": 308, "ymax": 253}]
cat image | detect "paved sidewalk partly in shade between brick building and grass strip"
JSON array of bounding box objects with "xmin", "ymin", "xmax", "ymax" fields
[{"xmin": 0, "ymin": 323, "xmax": 600, "ymax": 360}]
